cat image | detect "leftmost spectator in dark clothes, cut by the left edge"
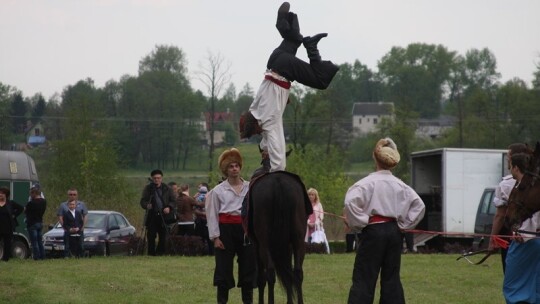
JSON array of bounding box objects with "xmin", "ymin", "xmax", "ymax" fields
[{"xmin": 0, "ymin": 187, "xmax": 24, "ymax": 262}]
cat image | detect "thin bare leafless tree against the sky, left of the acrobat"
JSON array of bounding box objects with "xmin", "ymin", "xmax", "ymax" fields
[{"xmin": 198, "ymin": 51, "xmax": 231, "ymax": 176}]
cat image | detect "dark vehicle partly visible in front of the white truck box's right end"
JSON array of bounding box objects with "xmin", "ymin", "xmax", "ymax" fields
[{"xmin": 473, "ymin": 187, "xmax": 497, "ymax": 249}]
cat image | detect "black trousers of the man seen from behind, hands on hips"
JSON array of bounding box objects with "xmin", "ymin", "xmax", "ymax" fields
[{"xmin": 348, "ymin": 222, "xmax": 405, "ymax": 304}]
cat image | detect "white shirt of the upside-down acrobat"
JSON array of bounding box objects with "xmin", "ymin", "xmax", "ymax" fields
[{"xmin": 249, "ymin": 79, "xmax": 289, "ymax": 172}]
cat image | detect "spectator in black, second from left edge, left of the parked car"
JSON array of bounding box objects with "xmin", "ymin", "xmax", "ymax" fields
[{"xmin": 24, "ymin": 188, "xmax": 47, "ymax": 260}]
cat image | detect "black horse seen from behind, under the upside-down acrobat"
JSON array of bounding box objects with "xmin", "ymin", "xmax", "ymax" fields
[{"xmin": 248, "ymin": 171, "xmax": 313, "ymax": 304}]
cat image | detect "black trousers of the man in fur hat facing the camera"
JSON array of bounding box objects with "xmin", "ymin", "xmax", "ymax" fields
[{"xmin": 214, "ymin": 224, "xmax": 257, "ymax": 289}]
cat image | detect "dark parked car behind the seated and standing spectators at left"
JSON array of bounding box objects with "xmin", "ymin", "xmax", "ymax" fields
[{"xmin": 43, "ymin": 211, "xmax": 136, "ymax": 257}]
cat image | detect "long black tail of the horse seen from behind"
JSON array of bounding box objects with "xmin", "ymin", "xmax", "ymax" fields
[{"xmin": 269, "ymin": 175, "xmax": 303, "ymax": 299}]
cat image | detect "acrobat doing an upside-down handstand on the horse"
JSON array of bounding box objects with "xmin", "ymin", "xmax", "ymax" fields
[{"xmin": 240, "ymin": 2, "xmax": 339, "ymax": 171}]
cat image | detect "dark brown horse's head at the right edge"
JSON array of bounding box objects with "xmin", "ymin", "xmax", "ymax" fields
[{"xmin": 505, "ymin": 142, "xmax": 540, "ymax": 231}]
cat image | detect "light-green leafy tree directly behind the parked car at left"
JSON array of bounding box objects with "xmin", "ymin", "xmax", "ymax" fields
[{"xmin": 45, "ymin": 79, "xmax": 126, "ymax": 202}]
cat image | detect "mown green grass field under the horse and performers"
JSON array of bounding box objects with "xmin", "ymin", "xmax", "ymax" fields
[{"xmin": 0, "ymin": 254, "xmax": 504, "ymax": 304}]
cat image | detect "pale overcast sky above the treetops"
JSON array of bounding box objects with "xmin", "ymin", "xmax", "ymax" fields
[{"xmin": 0, "ymin": 0, "xmax": 540, "ymax": 99}]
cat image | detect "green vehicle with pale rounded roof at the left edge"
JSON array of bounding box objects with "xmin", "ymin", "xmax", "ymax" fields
[{"xmin": 0, "ymin": 151, "xmax": 39, "ymax": 259}]
